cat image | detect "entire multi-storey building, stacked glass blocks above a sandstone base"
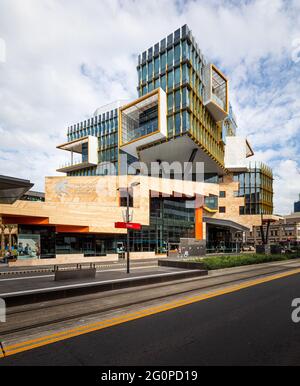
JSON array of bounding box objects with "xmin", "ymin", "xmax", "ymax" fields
[{"xmin": 0, "ymin": 25, "xmax": 273, "ymax": 257}]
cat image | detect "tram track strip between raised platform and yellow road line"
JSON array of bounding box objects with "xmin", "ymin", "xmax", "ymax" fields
[{"xmin": 0, "ymin": 264, "xmax": 295, "ymax": 341}]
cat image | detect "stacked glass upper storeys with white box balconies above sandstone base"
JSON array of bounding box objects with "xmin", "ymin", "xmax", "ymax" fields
[{"xmin": 58, "ymin": 25, "xmax": 270, "ymax": 196}]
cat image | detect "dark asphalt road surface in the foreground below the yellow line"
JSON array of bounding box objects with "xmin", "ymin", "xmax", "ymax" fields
[{"xmin": 0, "ymin": 274, "xmax": 300, "ymax": 366}]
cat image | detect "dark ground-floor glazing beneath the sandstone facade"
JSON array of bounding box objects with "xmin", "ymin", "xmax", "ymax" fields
[{"xmin": 19, "ymin": 197, "xmax": 195, "ymax": 258}]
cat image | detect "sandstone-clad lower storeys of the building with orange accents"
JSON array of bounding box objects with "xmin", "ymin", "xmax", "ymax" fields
[{"xmin": 0, "ymin": 175, "xmax": 278, "ymax": 264}]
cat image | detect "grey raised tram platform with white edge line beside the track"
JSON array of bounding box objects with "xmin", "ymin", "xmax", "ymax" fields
[{"xmin": 0, "ymin": 267, "xmax": 207, "ymax": 305}]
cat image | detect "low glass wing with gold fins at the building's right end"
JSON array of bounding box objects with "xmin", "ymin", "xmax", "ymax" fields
[{"xmin": 234, "ymin": 164, "xmax": 273, "ymax": 214}]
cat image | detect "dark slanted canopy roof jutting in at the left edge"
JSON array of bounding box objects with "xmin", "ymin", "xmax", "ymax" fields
[{"xmin": 0, "ymin": 176, "xmax": 34, "ymax": 204}]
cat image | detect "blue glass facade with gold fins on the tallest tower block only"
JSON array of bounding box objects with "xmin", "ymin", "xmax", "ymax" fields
[{"xmin": 137, "ymin": 25, "xmax": 224, "ymax": 166}]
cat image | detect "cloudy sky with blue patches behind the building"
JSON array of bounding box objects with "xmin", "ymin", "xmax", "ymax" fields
[{"xmin": 0, "ymin": 0, "xmax": 300, "ymax": 214}]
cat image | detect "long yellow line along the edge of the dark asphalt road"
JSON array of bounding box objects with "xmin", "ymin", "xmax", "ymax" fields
[{"xmin": 0, "ymin": 269, "xmax": 300, "ymax": 358}]
